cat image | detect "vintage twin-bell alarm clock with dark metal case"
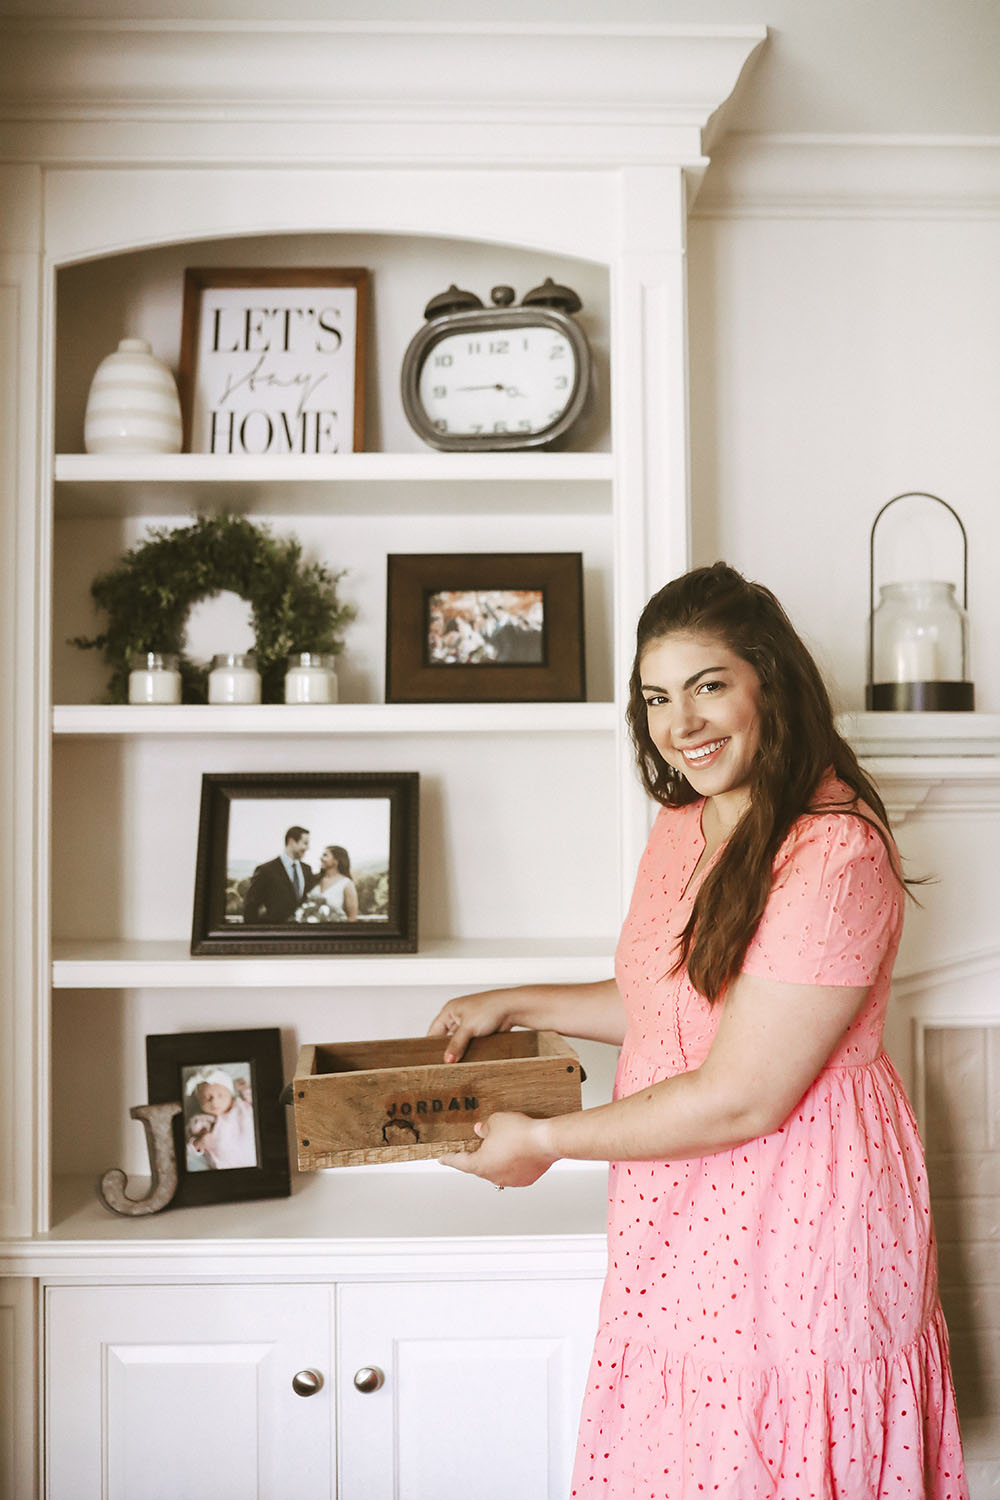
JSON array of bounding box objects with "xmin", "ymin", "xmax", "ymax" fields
[{"xmin": 402, "ymin": 278, "xmax": 591, "ymax": 453}]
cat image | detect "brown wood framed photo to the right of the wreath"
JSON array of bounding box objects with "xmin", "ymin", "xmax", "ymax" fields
[{"xmin": 385, "ymin": 552, "xmax": 585, "ymax": 704}]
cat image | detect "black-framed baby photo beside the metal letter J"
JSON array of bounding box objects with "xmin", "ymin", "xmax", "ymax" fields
[{"xmin": 145, "ymin": 1028, "xmax": 291, "ymax": 1206}]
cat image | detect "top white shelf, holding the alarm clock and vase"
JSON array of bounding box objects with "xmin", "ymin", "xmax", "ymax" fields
[{"xmin": 55, "ymin": 452, "xmax": 615, "ymax": 519}]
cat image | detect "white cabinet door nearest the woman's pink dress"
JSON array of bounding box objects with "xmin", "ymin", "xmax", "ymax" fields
[{"xmin": 337, "ymin": 1281, "xmax": 600, "ymax": 1500}]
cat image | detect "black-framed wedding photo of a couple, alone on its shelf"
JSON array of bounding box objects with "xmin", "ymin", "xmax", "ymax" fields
[{"xmin": 190, "ymin": 771, "xmax": 420, "ymax": 954}]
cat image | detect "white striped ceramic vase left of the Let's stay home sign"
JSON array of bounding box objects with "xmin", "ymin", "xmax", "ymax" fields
[{"xmin": 84, "ymin": 339, "xmax": 183, "ymax": 453}]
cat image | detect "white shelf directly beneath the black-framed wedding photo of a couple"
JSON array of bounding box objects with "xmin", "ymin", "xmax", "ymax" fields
[{"xmin": 52, "ymin": 936, "xmax": 616, "ymax": 990}]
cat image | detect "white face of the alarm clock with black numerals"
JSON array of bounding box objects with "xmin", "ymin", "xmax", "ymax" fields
[{"xmin": 417, "ymin": 324, "xmax": 577, "ymax": 443}]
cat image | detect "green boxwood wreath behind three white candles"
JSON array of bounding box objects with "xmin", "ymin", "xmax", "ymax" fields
[{"xmin": 72, "ymin": 516, "xmax": 354, "ymax": 704}]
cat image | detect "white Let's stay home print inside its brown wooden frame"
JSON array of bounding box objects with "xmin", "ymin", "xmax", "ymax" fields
[{"xmin": 190, "ymin": 287, "xmax": 358, "ymax": 456}]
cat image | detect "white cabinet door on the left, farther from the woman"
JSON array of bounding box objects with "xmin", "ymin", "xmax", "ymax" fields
[{"xmin": 45, "ymin": 1286, "xmax": 334, "ymax": 1500}]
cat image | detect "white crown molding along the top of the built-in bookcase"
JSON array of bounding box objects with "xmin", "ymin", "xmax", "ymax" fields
[{"xmin": 0, "ymin": 20, "xmax": 766, "ymax": 173}]
